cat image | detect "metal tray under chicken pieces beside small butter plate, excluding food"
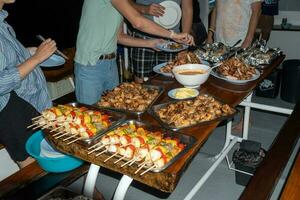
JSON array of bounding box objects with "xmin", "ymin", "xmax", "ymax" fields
[{"xmin": 149, "ymin": 94, "xmax": 237, "ymax": 131}]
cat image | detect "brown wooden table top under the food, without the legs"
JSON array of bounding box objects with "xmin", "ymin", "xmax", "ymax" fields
[{"xmin": 47, "ymin": 56, "xmax": 285, "ymax": 192}]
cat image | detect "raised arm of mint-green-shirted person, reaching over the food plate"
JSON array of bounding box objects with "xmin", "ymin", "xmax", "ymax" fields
[{"xmin": 111, "ymin": 0, "xmax": 193, "ymax": 44}]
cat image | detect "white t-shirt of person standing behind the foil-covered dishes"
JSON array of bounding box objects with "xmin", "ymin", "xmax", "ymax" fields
[{"xmin": 215, "ymin": 0, "xmax": 261, "ymax": 46}]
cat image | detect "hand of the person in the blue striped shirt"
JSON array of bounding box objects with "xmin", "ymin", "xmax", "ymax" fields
[{"xmin": 32, "ymin": 38, "xmax": 57, "ymax": 63}]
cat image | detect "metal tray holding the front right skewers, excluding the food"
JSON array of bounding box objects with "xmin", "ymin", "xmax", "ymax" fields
[{"xmin": 96, "ymin": 120, "xmax": 196, "ymax": 172}]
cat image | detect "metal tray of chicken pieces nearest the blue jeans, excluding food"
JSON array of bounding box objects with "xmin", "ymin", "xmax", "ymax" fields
[{"xmin": 97, "ymin": 84, "xmax": 164, "ymax": 115}]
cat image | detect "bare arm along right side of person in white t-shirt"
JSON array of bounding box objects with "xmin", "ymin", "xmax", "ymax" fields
[{"xmin": 241, "ymin": 1, "xmax": 261, "ymax": 48}]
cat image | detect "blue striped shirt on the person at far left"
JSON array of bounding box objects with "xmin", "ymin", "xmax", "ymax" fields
[{"xmin": 0, "ymin": 10, "xmax": 52, "ymax": 112}]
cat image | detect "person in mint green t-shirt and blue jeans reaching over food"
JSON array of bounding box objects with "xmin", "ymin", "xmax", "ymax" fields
[{"xmin": 75, "ymin": 0, "xmax": 193, "ymax": 104}]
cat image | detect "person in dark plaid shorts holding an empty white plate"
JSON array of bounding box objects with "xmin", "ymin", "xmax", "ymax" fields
[{"xmin": 130, "ymin": 0, "xmax": 193, "ymax": 82}]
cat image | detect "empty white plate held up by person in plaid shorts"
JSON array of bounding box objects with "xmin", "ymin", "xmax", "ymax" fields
[{"xmin": 153, "ymin": 1, "xmax": 181, "ymax": 29}]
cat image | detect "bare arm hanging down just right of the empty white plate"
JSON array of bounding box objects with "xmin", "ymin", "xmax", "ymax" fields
[{"xmin": 181, "ymin": 0, "xmax": 193, "ymax": 33}]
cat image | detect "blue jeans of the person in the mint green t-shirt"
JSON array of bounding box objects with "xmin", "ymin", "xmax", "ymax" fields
[{"xmin": 75, "ymin": 59, "xmax": 119, "ymax": 105}]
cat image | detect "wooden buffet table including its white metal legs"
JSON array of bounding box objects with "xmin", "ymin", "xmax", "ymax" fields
[{"xmin": 47, "ymin": 56, "xmax": 285, "ymax": 199}]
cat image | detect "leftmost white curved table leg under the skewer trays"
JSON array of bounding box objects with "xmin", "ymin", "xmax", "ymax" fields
[{"xmin": 83, "ymin": 164, "xmax": 100, "ymax": 198}]
